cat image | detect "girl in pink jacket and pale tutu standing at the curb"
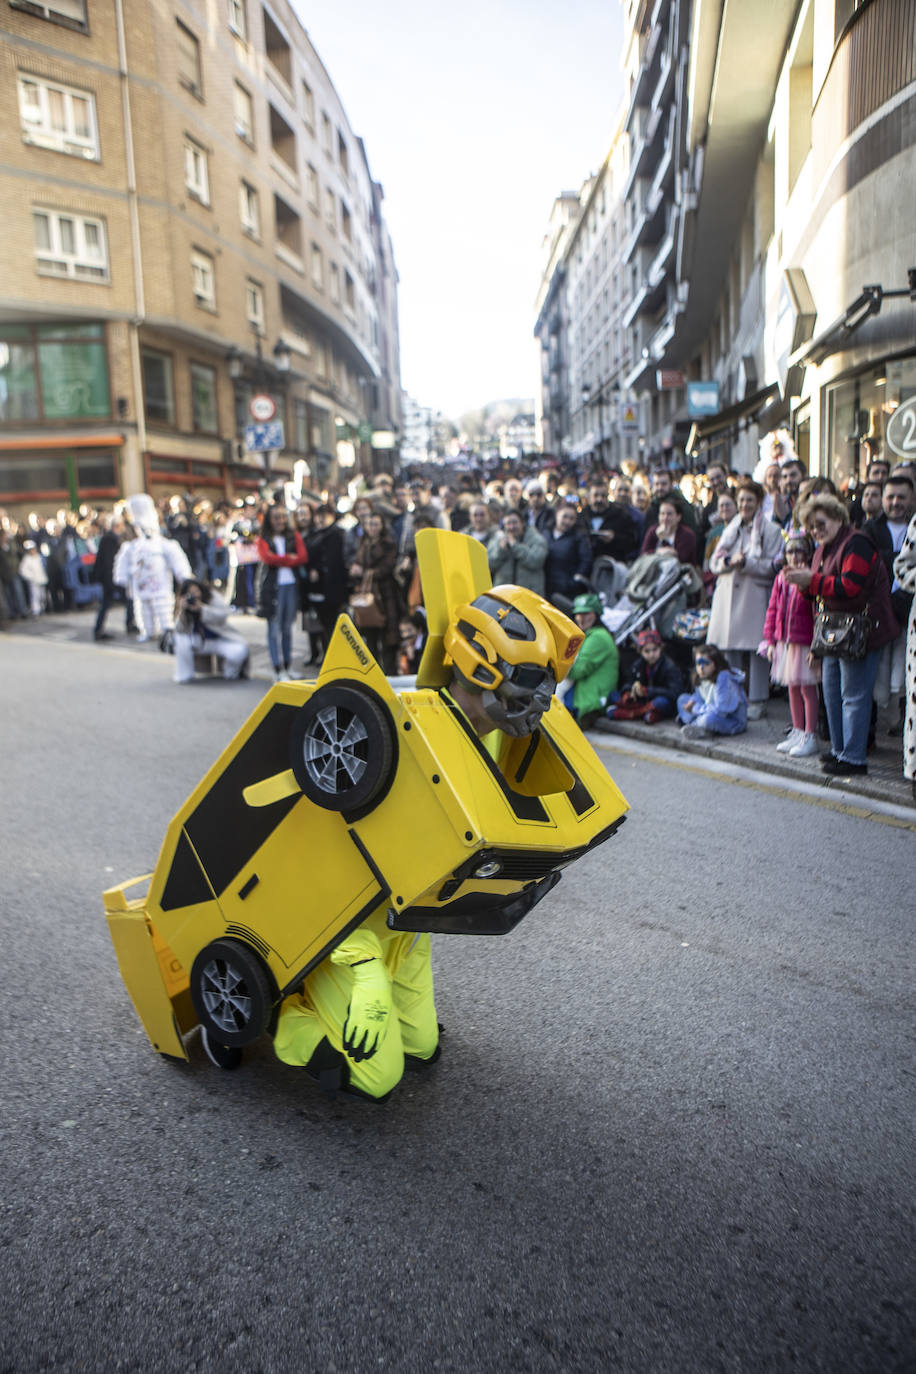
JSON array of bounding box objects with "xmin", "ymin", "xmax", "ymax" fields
[{"xmin": 758, "ymin": 529, "xmax": 820, "ymax": 758}]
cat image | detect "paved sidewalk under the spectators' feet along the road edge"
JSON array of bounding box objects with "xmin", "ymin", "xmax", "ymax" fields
[{"xmin": 7, "ymin": 605, "xmax": 916, "ymax": 811}]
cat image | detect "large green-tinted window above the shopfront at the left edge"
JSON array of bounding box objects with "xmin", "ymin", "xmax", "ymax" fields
[{"xmin": 0, "ymin": 324, "xmax": 111, "ymax": 423}]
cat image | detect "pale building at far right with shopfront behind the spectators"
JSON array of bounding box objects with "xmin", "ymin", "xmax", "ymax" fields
[{"xmin": 678, "ymin": 0, "xmax": 916, "ymax": 484}]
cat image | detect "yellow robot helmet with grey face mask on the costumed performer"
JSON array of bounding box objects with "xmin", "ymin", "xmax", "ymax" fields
[{"xmin": 442, "ymin": 585, "xmax": 584, "ymax": 735}]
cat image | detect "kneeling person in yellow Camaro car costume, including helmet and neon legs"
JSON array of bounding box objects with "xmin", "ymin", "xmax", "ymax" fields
[{"xmin": 104, "ymin": 530, "xmax": 626, "ymax": 1098}]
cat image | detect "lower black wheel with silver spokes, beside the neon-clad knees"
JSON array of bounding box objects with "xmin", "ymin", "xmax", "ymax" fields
[{"xmin": 191, "ymin": 940, "xmax": 273, "ymax": 1046}]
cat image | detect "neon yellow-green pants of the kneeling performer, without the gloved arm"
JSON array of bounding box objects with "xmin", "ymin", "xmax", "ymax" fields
[{"xmin": 273, "ymin": 912, "xmax": 439, "ymax": 1098}]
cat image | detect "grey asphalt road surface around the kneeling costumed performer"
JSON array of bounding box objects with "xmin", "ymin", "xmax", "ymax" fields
[{"xmin": 0, "ymin": 638, "xmax": 916, "ymax": 1374}]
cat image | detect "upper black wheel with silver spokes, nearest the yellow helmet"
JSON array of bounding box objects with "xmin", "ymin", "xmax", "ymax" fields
[{"xmin": 290, "ymin": 683, "xmax": 396, "ymax": 812}]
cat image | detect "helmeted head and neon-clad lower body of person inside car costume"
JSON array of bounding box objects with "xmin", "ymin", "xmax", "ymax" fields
[{"xmin": 273, "ymin": 585, "xmax": 585, "ymax": 1101}]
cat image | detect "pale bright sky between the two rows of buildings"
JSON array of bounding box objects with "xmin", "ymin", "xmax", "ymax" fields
[{"xmin": 294, "ymin": 0, "xmax": 623, "ymax": 416}]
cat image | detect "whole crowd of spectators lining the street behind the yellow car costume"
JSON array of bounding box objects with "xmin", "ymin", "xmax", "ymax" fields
[{"xmin": 0, "ymin": 430, "xmax": 916, "ymax": 797}]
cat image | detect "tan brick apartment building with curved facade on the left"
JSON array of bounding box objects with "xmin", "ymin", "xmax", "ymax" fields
[{"xmin": 0, "ymin": 0, "xmax": 400, "ymax": 510}]
